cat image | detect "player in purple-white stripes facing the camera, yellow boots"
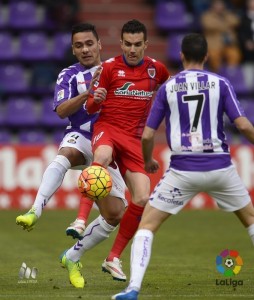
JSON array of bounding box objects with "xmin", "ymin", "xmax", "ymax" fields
[{"xmin": 16, "ymin": 23, "xmax": 127, "ymax": 288}]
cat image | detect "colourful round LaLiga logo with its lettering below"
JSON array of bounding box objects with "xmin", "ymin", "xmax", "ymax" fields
[{"xmin": 216, "ymin": 249, "xmax": 243, "ymax": 287}]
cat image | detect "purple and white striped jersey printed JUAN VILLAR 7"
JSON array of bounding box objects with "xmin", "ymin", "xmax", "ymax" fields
[{"xmin": 147, "ymin": 70, "xmax": 245, "ymax": 171}]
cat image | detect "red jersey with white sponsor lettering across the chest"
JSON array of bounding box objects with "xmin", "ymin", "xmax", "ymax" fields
[{"xmin": 86, "ymin": 55, "xmax": 169, "ymax": 137}]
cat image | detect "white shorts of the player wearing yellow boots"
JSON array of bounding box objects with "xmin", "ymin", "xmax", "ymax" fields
[{"xmin": 58, "ymin": 131, "xmax": 128, "ymax": 206}]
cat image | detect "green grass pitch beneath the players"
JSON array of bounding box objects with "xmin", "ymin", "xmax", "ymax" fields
[{"xmin": 0, "ymin": 210, "xmax": 254, "ymax": 300}]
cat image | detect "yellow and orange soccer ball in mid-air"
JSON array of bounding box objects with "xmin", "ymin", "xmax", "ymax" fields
[{"xmin": 78, "ymin": 166, "xmax": 112, "ymax": 200}]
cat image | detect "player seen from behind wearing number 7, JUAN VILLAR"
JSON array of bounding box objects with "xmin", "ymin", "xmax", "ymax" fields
[{"xmin": 112, "ymin": 33, "xmax": 254, "ymax": 300}]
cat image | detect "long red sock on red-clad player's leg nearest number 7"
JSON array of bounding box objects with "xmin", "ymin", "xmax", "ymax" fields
[{"xmin": 107, "ymin": 202, "xmax": 144, "ymax": 261}]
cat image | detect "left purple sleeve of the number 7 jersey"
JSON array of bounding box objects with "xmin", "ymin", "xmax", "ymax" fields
[{"xmin": 146, "ymin": 84, "xmax": 169, "ymax": 130}]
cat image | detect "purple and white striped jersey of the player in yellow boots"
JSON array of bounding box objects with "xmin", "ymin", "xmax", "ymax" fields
[{"xmin": 53, "ymin": 63, "xmax": 98, "ymax": 140}]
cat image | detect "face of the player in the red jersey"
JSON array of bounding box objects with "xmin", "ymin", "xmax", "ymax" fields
[{"xmin": 121, "ymin": 32, "xmax": 148, "ymax": 66}]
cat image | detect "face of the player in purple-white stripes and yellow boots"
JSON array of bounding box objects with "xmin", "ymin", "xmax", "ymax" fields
[{"xmin": 72, "ymin": 32, "xmax": 101, "ymax": 68}]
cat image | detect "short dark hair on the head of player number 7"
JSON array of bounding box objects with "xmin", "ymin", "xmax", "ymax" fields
[{"xmin": 181, "ymin": 33, "xmax": 208, "ymax": 62}]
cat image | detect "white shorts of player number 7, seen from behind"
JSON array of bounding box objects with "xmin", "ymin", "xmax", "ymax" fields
[{"xmin": 150, "ymin": 165, "xmax": 251, "ymax": 214}]
